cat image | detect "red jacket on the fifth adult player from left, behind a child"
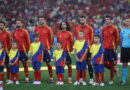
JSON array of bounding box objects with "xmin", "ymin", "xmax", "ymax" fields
[{"xmin": 74, "ymin": 25, "xmax": 94, "ymax": 47}]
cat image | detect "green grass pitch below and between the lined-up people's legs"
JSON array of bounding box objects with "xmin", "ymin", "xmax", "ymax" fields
[{"xmin": 3, "ymin": 52, "xmax": 130, "ymax": 90}]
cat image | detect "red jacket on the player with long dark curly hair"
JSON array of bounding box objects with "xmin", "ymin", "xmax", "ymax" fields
[{"xmin": 57, "ymin": 31, "xmax": 74, "ymax": 51}]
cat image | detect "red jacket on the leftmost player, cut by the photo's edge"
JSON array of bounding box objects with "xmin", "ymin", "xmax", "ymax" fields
[{"xmin": 0, "ymin": 30, "xmax": 11, "ymax": 53}]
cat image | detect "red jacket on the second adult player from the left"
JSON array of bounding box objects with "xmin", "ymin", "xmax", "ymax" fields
[{"xmin": 12, "ymin": 29, "xmax": 30, "ymax": 52}]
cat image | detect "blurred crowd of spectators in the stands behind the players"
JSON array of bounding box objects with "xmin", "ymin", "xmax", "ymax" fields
[{"xmin": 0, "ymin": 0, "xmax": 130, "ymax": 31}]
